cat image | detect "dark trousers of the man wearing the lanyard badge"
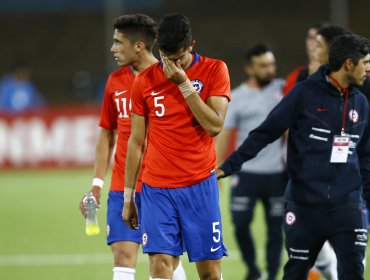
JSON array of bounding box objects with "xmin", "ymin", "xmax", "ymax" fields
[{"xmin": 283, "ymin": 202, "xmax": 367, "ymax": 280}]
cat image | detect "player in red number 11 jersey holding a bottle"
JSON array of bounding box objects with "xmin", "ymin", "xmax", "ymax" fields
[{"xmin": 80, "ymin": 14, "xmax": 184, "ymax": 280}]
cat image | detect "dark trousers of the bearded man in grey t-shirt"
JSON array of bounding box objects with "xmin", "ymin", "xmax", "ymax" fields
[{"xmin": 231, "ymin": 172, "xmax": 287, "ymax": 280}]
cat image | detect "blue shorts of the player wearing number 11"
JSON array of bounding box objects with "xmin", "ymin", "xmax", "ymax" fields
[{"xmin": 107, "ymin": 191, "xmax": 141, "ymax": 245}]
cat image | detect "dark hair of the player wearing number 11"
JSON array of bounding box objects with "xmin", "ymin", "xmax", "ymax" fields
[{"xmin": 113, "ymin": 14, "xmax": 157, "ymax": 51}]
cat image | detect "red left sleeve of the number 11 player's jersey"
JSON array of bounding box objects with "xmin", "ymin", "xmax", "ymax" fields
[{"xmin": 99, "ymin": 77, "xmax": 117, "ymax": 130}]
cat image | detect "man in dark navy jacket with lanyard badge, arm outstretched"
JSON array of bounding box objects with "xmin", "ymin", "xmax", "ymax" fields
[{"xmin": 217, "ymin": 34, "xmax": 370, "ymax": 280}]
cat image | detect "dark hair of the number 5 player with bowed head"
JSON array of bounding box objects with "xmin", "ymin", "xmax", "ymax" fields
[{"xmin": 157, "ymin": 14, "xmax": 193, "ymax": 53}]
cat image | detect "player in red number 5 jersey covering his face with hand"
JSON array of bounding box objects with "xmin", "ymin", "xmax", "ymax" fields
[{"xmin": 123, "ymin": 14, "xmax": 230, "ymax": 279}]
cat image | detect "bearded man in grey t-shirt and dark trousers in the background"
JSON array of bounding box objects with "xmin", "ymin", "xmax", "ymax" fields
[{"xmin": 216, "ymin": 44, "xmax": 287, "ymax": 280}]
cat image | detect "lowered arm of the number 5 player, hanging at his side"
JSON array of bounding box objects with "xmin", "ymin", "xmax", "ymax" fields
[{"xmin": 122, "ymin": 113, "xmax": 146, "ymax": 229}]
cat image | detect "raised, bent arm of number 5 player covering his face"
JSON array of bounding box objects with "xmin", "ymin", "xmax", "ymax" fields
[{"xmin": 162, "ymin": 57, "xmax": 228, "ymax": 136}]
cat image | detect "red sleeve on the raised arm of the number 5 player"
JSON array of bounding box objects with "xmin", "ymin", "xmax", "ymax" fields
[{"xmin": 209, "ymin": 61, "xmax": 231, "ymax": 101}]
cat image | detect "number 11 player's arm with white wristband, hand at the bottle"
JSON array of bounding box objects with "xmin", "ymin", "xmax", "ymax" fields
[{"xmin": 80, "ymin": 128, "xmax": 116, "ymax": 215}]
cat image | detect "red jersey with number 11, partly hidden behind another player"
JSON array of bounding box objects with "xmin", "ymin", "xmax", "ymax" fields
[{"xmin": 99, "ymin": 66, "xmax": 141, "ymax": 191}]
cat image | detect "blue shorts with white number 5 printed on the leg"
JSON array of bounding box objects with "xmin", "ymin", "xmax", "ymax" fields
[{"xmin": 141, "ymin": 175, "xmax": 228, "ymax": 262}]
